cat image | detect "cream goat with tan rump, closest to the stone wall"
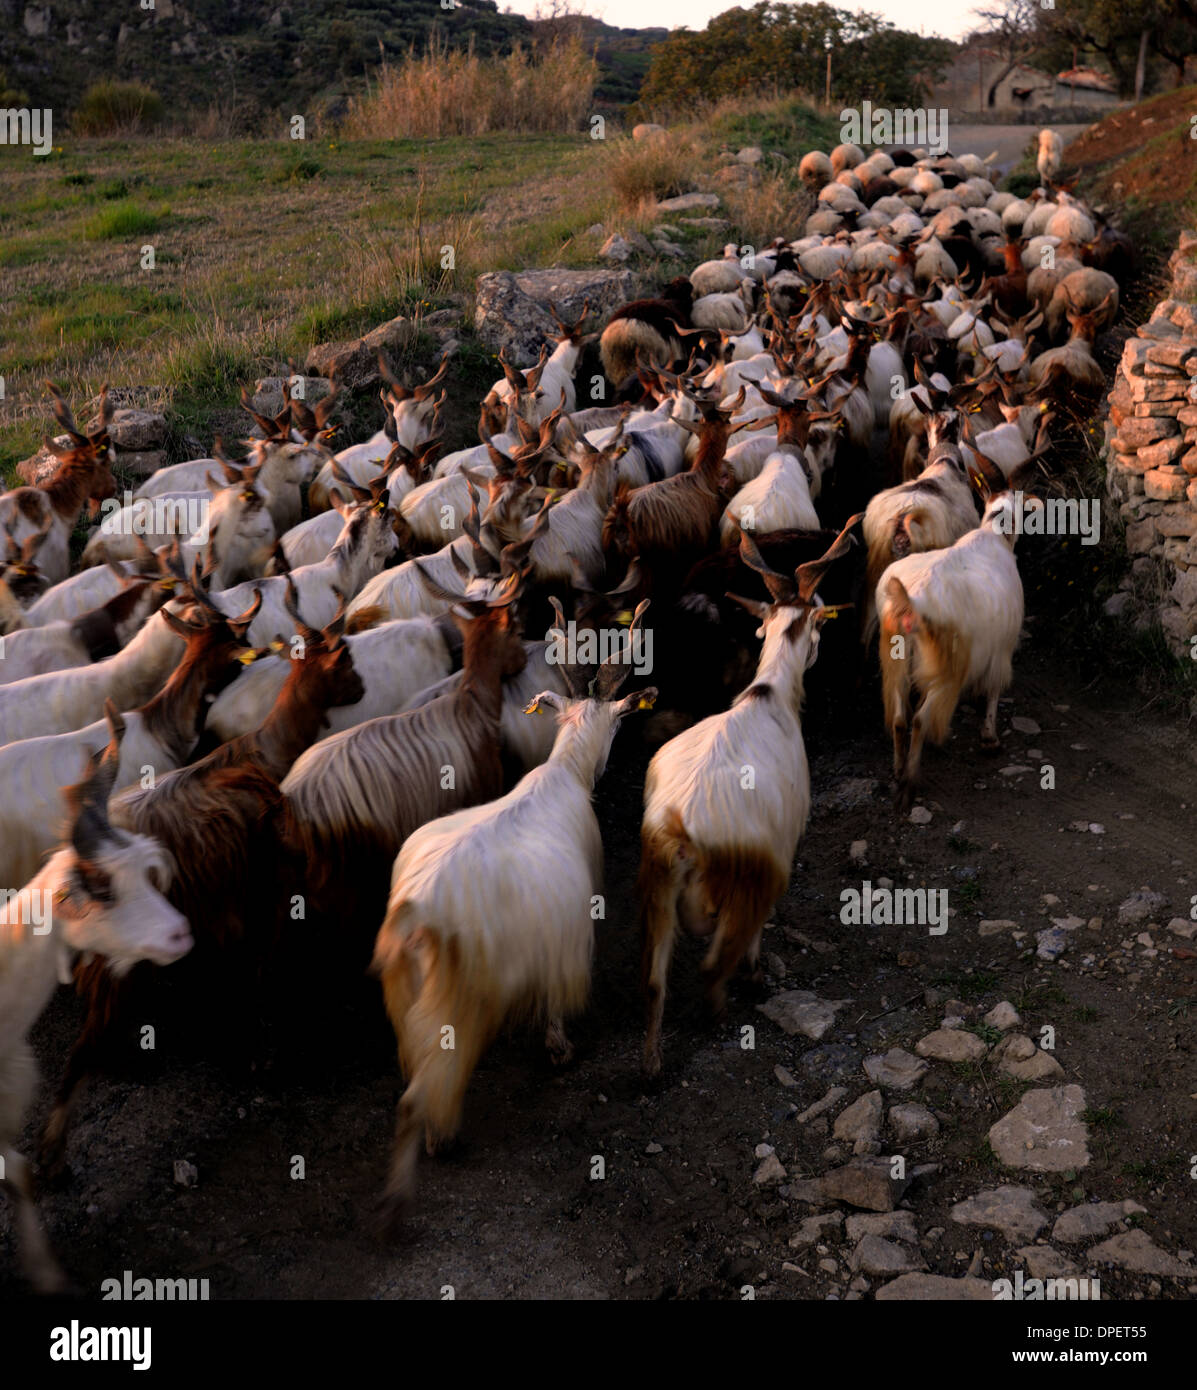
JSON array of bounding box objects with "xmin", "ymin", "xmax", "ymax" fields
[{"xmin": 876, "ymin": 492, "xmax": 1043, "ymax": 810}]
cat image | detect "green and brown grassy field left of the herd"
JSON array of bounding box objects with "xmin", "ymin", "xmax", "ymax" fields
[{"xmin": 0, "ymin": 103, "xmax": 829, "ymax": 473}]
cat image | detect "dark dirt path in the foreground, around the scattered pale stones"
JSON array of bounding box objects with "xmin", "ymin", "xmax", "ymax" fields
[{"xmin": 0, "ymin": 621, "xmax": 1197, "ymax": 1298}]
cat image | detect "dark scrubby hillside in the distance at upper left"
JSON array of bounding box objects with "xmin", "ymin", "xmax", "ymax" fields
[{"xmin": 0, "ymin": 0, "xmax": 666, "ymax": 115}]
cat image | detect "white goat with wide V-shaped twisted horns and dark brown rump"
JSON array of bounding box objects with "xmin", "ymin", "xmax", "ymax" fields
[{"xmin": 638, "ymin": 516, "xmax": 859, "ymax": 1076}]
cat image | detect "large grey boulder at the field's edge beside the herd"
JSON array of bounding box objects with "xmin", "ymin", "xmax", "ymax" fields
[{"xmin": 474, "ymin": 270, "xmax": 638, "ymax": 367}]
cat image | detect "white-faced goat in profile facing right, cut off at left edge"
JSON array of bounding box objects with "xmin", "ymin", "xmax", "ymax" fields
[{"xmin": 0, "ymin": 706, "xmax": 192, "ymax": 1294}]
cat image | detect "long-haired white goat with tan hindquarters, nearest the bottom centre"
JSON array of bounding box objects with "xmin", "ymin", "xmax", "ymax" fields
[{"xmin": 374, "ymin": 605, "xmax": 656, "ymax": 1229}]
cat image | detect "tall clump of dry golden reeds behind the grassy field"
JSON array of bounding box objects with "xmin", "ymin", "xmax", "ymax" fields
[{"xmin": 341, "ymin": 39, "xmax": 598, "ymax": 139}]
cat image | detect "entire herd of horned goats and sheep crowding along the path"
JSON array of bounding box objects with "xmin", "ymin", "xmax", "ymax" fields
[{"xmin": 0, "ymin": 132, "xmax": 1132, "ymax": 1291}]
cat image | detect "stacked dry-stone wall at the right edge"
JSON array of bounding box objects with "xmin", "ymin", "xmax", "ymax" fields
[{"xmin": 1107, "ymin": 232, "xmax": 1197, "ymax": 655}]
